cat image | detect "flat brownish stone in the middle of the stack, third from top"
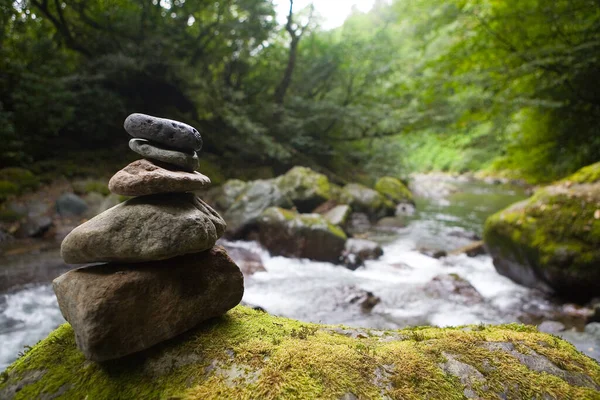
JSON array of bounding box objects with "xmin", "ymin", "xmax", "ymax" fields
[{"xmin": 108, "ymin": 160, "xmax": 210, "ymax": 196}]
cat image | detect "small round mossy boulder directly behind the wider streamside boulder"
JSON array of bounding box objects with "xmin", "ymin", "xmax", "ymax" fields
[{"xmin": 276, "ymin": 167, "xmax": 332, "ymax": 212}]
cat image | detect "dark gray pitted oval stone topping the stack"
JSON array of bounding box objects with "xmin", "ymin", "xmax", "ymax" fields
[{"xmin": 123, "ymin": 113, "xmax": 202, "ymax": 152}]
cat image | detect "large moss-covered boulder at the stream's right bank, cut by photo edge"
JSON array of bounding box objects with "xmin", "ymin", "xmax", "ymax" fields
[{"xmin": 484, "ymin": 163, "xmax": 600, "ymax": 301}]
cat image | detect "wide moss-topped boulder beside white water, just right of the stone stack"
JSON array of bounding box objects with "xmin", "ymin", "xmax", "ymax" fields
[{"xmin": 257, "ymin": 207, "xmax": 347, "ymax": 263}]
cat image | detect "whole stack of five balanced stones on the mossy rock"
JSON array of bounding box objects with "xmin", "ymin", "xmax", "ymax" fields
[{"xmin": 53, "ymin": 114, "xmax": 244, "ymax": 361}]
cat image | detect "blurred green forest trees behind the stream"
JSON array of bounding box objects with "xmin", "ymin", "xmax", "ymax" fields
[{"xmin": 0, "ymin": 0, "xmax": 600, "ymax": 183}]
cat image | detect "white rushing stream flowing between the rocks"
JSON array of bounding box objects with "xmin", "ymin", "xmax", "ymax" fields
[{"xmin": 0, "ymin": 180, "xmax": 600, "ymax": 371}]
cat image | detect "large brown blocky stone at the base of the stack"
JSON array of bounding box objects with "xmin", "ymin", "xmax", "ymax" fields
[{"xmin": 53, "ymin": 246, "xmax": 244, "ymax": 361}]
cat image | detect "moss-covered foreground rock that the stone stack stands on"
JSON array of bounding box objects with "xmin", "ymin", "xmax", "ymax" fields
[{"xmin": 0, "ymin": 307, "xmax": 600, "ymax": 400}]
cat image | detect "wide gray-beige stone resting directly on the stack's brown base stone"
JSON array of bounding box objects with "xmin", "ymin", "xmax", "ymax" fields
[{"xmin": 61, "ymin": 193, "xmax": 226, "ymax": 264}]
